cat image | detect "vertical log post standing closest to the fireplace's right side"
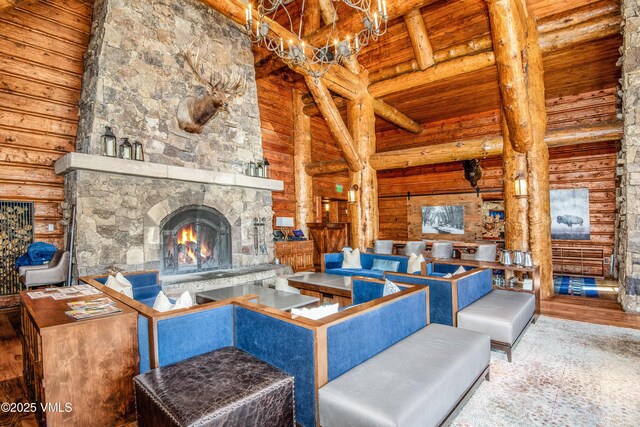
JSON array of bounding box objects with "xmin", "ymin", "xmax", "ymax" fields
[{"xmin": 293, "ymin": 89, "xmax": 314, "ymax": 236}]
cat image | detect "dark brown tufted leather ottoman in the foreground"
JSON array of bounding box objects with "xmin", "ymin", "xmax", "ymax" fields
[{"xmin": 134, "ymin": 347, "xmax": 295, "ymax": 427}]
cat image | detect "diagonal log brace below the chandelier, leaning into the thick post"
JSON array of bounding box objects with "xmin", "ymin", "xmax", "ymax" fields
[{"xmin": 305, "ymin": 76, "xmax": 362, "ymax": 172}]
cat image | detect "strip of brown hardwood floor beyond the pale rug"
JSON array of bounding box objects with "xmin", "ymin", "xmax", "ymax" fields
[{"xmin": 540, "ymin": 295, "xmax": 640, "ymax": 329}]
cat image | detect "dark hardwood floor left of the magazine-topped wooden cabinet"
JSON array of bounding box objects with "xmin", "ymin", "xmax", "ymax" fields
[{"xmin": 0, "ymin": 309, "xmax": 38, "ymax": 427}]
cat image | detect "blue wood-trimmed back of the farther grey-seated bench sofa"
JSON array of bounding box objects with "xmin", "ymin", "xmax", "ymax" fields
[{"xmin": 384, "ymin": 263, "xmax": 493, "ymax": 326}]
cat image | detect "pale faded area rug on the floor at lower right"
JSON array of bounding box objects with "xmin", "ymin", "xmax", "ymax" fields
[{"xmin": 452, "ymin": 316, "xmax": 640, "ymax": 427}]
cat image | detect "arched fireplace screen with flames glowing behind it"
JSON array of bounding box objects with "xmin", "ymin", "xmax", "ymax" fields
[{"xmin": 162, "ymin": 206, "xmax": 231, "ymax": 274}]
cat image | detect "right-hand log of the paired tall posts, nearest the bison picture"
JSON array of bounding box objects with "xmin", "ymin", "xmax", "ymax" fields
[{"xmin": 523, "ymin": 9, "xmax": 553, "ymax": 299}]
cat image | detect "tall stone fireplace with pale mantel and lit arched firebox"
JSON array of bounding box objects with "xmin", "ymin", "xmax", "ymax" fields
[{"xmin": 56, "ymin": 0, "xmax": 283, "ymax": 280}]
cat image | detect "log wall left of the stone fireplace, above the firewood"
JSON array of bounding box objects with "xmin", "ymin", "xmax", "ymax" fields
[{"xmin": 0, "ymin": 0, "xmax": 93, "ymax": 251}]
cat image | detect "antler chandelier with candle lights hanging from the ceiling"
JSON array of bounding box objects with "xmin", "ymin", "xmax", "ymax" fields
[{"xmin": 245, "ymin": 0, "xmax": 389, "ymax": 82}]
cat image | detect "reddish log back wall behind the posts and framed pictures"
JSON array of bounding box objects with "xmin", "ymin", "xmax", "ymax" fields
[{"xmin": 378, "ymin": 89, "xmax": 618, "ymax": 280}]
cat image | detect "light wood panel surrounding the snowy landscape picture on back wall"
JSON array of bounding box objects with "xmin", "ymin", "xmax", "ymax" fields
[{"xmin": 407, "ymin": 193, "xmax": 482, "ymax": 241}]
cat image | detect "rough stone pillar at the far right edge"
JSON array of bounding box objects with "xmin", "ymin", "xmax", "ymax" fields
[{"xmin": 617, "ymin": 0, "xmax": 640, "ymax": 313}]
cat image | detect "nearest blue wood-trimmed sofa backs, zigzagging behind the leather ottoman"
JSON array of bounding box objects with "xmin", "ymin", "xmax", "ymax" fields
[{"xmin": 81, "ymin": 273, "xmax": 488, "ymax": 427}]
